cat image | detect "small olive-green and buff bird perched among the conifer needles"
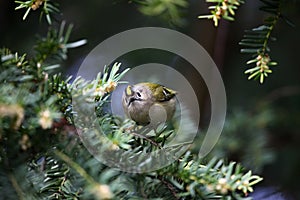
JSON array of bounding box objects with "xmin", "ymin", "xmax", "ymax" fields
[{"xmin": 122, "ymin": 82, "xmax": 177, "ymax": 125}]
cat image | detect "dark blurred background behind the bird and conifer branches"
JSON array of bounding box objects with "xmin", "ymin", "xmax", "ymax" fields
[{"xmin": 0, "ymin": 0, "xmax": 300, "ymax": 199}]
